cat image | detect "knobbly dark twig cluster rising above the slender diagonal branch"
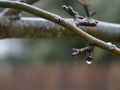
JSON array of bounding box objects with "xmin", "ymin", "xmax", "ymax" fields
[{"xmin": 62, "ymin": 0, "xmax": 98, "ymax": 27}]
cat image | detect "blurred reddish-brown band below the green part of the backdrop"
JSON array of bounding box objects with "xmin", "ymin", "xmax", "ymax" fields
[{"xmin": 0, "ymin": 63, "xmax": 120, "ymax": 90}]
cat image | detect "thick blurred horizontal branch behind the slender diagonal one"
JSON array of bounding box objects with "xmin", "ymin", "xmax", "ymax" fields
[{"xmin": 0, "ymin": 17, "xmax": 120, "ymax": 43}]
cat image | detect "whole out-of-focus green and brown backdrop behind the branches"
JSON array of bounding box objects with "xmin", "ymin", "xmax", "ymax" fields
[{"xmin": 0, "ymin": 0, "xmax": 120, "ymax": 90}]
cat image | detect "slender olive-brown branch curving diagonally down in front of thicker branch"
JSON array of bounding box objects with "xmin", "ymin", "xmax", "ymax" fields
[{"xmin": 0, "ymin": 1, "xmax": 120, "ymax": 56}]
